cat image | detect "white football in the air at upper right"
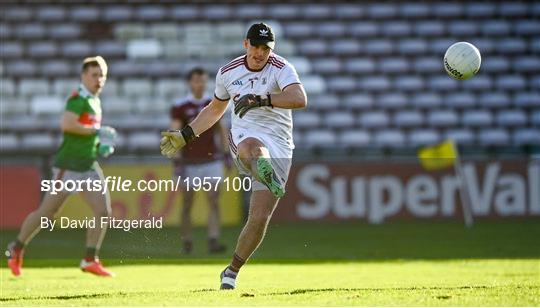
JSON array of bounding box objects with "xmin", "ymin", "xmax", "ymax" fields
[{"xmin": 444, "ymin": 42, "xmax": 482, "ymax": 80}]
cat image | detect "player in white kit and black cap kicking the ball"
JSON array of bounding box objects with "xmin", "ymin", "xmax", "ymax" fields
[{"xmin": 161, "ymin": 23, "xmax": 307, "ymax": 289}]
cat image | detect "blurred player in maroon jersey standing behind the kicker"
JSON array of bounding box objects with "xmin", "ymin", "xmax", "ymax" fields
[{"xmin": 171, "ymin": 67, "xmax": 231, "ymax": 254}]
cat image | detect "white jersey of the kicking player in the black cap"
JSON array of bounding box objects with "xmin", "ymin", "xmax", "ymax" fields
[{"xmin": 214, "ymin": 53, "xmax": 300, "ymax": 148}]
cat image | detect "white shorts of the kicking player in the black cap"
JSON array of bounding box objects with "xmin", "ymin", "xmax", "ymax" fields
[{"xmin": 229, "ymin": 128, "xmax": 293, "ymax": 191}]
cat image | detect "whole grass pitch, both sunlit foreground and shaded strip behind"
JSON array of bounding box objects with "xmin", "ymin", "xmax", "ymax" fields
[{"xmin": 0, "ymin": 220, "xmax": 540, "ymax": 306}]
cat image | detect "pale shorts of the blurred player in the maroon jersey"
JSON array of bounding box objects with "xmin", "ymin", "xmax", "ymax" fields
[{"xmin": 175, "ymin": 159, "xmax": 224, "ymax": 189}]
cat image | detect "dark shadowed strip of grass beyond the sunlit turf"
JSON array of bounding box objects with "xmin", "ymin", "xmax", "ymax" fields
[{"xmin": 0, "ymin": 219, "xmax": 540, "ymax": 267}]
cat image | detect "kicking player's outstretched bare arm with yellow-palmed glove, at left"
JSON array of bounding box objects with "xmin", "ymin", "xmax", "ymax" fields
[{"xmin": 160, "ymin": 97, "xmax": 227, "ymax": 158}]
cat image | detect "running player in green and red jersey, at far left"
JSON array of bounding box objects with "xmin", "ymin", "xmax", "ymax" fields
[{"xmin": 6, "ymin": 56, "xmax": 116, "ymax": 276}]
